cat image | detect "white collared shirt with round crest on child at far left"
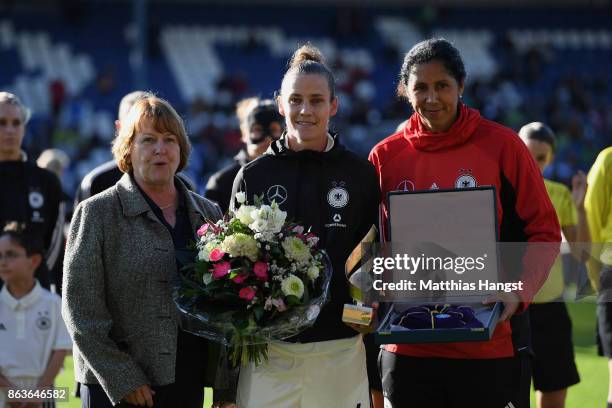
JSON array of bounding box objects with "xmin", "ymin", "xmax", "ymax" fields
[{"xmin": 0, "ymin": 281, "xmax": 72, "ymax": 377}]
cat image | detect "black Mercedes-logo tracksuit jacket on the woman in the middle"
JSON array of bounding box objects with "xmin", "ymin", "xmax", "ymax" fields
[{"xmin": 232, "ymin": 135, "xmax": 380, "ymax": 343}]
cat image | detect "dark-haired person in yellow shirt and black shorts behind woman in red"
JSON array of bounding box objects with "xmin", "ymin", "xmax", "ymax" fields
[{"xmin": 519, "ymin": 122, "xmax": 590, "ymax": 408}]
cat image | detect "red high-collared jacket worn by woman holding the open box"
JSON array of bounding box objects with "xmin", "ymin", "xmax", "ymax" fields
[{"xmin": 369, "ymin": 104, "xmax": 561, "ymax": 359}]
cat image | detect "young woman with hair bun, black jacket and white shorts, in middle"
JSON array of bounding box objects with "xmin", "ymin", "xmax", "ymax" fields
[{"xmin": 233, "ymin": 45, "xmax": 380, "ymax": 408}]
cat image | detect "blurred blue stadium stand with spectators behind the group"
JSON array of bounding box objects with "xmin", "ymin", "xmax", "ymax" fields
[{"xmin": 0, "ymin": 1, "xmax": 612, "ymax": 202}]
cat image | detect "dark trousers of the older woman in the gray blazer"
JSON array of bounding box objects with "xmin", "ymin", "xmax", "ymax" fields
[{"xmin": 81, "ymin": 330, "xmax": 208, "ymax": 408}]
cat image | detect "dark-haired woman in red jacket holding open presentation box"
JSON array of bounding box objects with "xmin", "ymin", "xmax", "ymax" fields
[{"xmin": 370, "ymin": 39, "xmax": 560, "ymax": 408}]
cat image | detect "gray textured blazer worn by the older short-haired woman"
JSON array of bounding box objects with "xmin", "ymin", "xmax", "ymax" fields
[{"xmin": 62, "ymin": 174, "xmax": 221, "ymax": 404}]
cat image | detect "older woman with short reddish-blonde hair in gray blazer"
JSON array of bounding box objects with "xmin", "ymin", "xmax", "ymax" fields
[{"xmin": 62, "ymin": 94, "xmax": 221, "ymax": 408}]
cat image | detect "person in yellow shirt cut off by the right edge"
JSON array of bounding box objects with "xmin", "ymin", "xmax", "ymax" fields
[{"xmin": 585, "ymin": 147, "xmax": 612, "ymax": 408}]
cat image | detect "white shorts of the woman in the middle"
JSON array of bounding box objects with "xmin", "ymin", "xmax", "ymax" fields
[{"xmin": 237, "ymin": 335, "xmax": 370, "ymax": 408}]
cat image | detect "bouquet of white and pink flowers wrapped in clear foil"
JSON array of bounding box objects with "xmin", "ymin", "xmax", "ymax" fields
[{"xmin": 174, "ymin": 193, "xmax": 332, "ymax": 365}]
